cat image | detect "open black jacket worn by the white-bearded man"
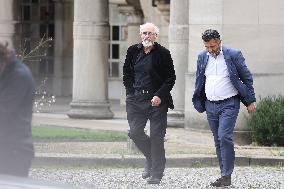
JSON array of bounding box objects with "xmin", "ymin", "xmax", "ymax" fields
[{"xmin": 123, "ymin": 42, "xmax": 176, "ymax": 109}]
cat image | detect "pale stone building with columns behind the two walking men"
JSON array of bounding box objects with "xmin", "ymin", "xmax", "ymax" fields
[{"xmin": 0, "ymin": 0, "xmax": 284, "ymax": 134}]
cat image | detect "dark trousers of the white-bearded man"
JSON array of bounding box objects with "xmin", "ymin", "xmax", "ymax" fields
[{"xmin": 126, "ymin": 94, "xmax": 168, "ymax": 177}]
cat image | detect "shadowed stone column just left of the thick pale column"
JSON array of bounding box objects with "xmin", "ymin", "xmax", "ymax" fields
[{"xmin": 53, "ymin": 0, "xmax": 74, "ymax": 96}]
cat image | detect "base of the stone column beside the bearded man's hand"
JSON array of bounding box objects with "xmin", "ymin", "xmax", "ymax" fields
[{"xmin": 168, "ymin": 110, "xmax": 184, "ymax": 128}]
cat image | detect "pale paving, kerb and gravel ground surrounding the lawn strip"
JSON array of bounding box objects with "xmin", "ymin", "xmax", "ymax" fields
[{"xmin": 30, "ymin": 96, "xmax": 284, "ymax": 189}]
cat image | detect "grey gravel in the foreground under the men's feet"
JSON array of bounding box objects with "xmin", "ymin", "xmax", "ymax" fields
[{"xmin": 30, "ymin": 167, "xmax": 284, "ymax": 189}]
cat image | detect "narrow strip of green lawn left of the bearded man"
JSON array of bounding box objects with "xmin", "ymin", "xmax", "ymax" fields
[{"xmin": 32, "ymin": 125, "xmax": 127, "ymax": 142}]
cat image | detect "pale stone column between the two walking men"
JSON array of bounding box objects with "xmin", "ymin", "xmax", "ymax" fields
[{"xmin": 168, "ymin": 0, "xmax": 188, "ymax": 127}]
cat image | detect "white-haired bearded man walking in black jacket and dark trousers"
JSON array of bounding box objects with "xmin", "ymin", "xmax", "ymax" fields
[{"xmin": 123, "ymin": 23, "xmax": 176, "ymax": 184}]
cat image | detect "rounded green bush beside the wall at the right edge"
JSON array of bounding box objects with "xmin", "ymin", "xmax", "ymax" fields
[{"xmin": 248, "ymin": 96, "xmax": 284, "ymax": 146}]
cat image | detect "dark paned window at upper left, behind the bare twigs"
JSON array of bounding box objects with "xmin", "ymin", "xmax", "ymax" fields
[{"xmin": 20, "ymin": 0, "xmax": 55, "ymax": 75}]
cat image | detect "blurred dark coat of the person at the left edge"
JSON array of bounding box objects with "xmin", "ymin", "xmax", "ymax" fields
[{"xmin": 0, "ymin": 58, "xmax": 35, "ymax": 157}]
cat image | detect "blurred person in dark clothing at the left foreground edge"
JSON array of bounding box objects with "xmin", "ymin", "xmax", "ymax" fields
[{"xmin": 0, "ymin": 43, "xmax": 35, "ymax": 177}]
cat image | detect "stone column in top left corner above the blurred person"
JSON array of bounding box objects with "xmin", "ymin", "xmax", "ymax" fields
[{"xmin": 0, "ymin": 0, "xmax": 17, "ymax": 48}]
